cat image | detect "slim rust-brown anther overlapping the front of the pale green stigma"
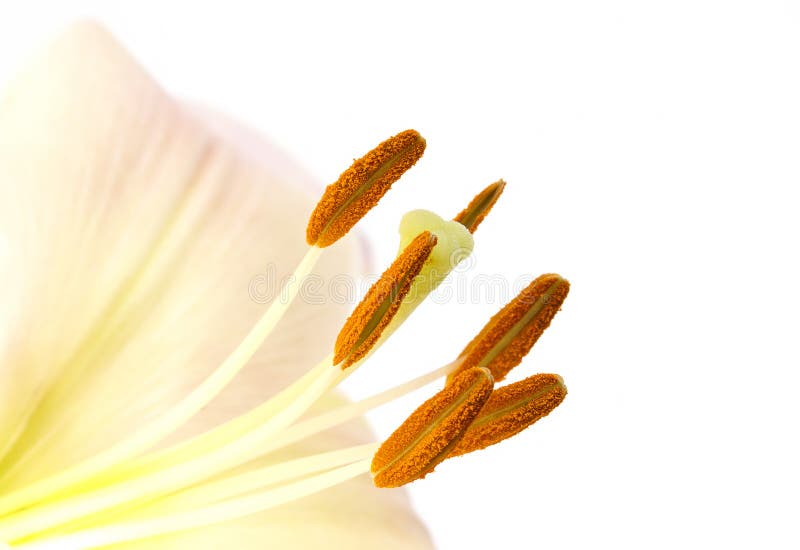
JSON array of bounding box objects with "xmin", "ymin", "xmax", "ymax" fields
[{"xmin": 333, "ymin": 231, "xmax": 437, "ymax": 370}]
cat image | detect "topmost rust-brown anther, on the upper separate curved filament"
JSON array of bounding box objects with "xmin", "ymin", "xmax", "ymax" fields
[{"xmin": 306, "ymin": 130, "xmax": 425, "ymax": 248}]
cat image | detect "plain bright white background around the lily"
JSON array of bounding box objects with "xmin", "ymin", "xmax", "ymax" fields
[{"xmin": 0, "ymin": 0, "xmax": 800, "ymax": 550}]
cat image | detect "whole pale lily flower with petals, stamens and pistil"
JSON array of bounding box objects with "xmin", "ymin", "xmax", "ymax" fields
[{"xmin": 0, "ymin": 23, "xmax": 569, "ymax": 550}]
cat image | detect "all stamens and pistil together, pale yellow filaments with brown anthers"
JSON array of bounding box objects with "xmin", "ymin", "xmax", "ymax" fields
[{"xmin": 0, "ymin": 131, "xmax": 569, "ymax": 550}]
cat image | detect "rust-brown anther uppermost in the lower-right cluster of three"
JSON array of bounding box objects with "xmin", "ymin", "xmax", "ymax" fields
[{"xmin": 448, "ymin": 273, "xmax": 569, "ymax": 383}]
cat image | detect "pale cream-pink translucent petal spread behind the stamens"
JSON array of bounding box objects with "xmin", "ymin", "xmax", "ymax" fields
[{"xmin": 0, "ymin": 23, "xmax": 427, "ymax": 548}]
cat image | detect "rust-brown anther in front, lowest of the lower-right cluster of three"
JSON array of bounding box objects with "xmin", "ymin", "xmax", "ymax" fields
[{"xmin": 371, "ymin": 368, "xmax": 494, "ymax": 487}]
